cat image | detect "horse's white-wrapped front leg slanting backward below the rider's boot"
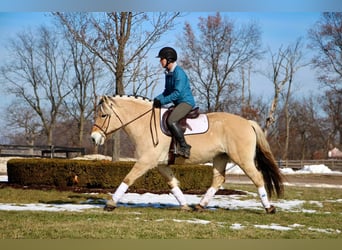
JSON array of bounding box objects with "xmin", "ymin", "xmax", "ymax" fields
[{"xmin": 158, "ymin": 165, "xmax": 190, "ymax": 210}]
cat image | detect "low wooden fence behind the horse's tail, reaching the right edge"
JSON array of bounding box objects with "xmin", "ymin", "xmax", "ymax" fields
[{"xmin": 278, "ymin": 159, "xmax": 342, "ymax": 171}]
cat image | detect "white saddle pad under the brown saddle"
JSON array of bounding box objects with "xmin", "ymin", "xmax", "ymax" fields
[{"xmin": 160, "ymin": 108, "xmax": 209, "ymax": 135}]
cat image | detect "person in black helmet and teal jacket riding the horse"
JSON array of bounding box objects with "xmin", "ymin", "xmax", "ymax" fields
[{"xmin": 153, "ymin": 47, "xmax": 195, "ymax": 158}]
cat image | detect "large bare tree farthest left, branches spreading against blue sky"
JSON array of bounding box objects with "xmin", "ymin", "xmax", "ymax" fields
[{"xmin": 1, "ymin": 26, "xmax": 69, "ymax": 144}]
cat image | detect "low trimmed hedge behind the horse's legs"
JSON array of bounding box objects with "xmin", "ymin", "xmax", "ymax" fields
[{"xmin": 7, "ymin": 159, "xmax": 213, "ymax": 192}]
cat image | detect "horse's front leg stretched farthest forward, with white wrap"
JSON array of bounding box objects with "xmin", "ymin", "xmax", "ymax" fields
[{"xmin": 104, "ymin": 161, "xmax": 156, "ymax": 211}]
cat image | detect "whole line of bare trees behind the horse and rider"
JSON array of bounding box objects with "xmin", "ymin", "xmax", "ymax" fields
[{"xmin": 0, "ymin": 12, "xmax": 342, "ymax": 160}]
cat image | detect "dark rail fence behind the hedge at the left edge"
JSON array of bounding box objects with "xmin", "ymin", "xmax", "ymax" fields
[{"xmin": 0, "ymin": 144, "xmax": 85, "ymax": 158}]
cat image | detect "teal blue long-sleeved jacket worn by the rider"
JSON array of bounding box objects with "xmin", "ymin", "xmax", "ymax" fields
[{"xmin": 156, "ymin": 65, "xmax": 195, "ymax": 108}]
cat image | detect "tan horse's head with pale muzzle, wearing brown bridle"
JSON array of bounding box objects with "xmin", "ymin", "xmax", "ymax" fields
[{"xmin": 91, "ymin": 96, "xmax": 122, "ymax": 145}]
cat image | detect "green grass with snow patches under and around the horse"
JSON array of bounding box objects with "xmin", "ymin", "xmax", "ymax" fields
[{"xmin": 0, "ymin": 185, "xmax": 342, "ymax": 239}]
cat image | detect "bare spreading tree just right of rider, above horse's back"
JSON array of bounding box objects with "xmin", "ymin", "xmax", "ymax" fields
[{"xmin": 179, "ymin": 13, "xmax": 262, "ymax": 111}]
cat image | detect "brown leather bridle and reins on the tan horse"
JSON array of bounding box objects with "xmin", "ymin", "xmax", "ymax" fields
[{"xmin": 93, "ymin": 105, "xmax": 159, "ymax": 146}]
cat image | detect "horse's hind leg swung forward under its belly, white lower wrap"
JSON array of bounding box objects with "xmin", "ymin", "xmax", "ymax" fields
[{"xmin": 195, "ymin": 154, "xmax": 228, "ymax": 210}]
